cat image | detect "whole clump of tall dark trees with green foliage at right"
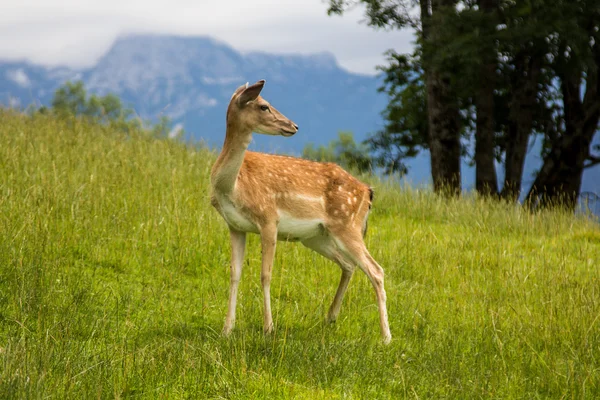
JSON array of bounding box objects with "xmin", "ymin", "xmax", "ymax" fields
[{"xmin": 329, "ymin": 0, "xmax": 600, "ymax": 208}]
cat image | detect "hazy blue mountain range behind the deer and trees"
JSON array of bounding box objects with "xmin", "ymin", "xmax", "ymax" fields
[{"xmin": 0, "ymin": 35, "xmax": 600, "ymax": 203}]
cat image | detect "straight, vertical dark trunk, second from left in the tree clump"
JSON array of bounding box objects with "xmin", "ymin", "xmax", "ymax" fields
[{"xmin": 475, "ymin": 0, "xmax": 498, "ymax": 196}]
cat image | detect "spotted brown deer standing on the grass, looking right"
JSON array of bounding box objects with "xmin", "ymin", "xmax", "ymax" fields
[{"xmin": 210, "ymin": 80, "xmax": 392, "ymax": 344}]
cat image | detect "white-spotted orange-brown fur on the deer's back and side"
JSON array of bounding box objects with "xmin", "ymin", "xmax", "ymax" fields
[{"xmin": 229, "ymin": 151, "xmax": 371, "ymax": 236}]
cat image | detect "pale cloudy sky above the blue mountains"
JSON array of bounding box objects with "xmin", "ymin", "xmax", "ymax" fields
[{"xmin": 0, "ymin": 0, "xmax": 413, "ymax": 74}]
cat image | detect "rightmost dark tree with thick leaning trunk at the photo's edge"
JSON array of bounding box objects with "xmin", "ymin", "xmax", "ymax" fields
[{"xmin": 527, "ymin": 0, "xmax": 600, "ymax": 209}]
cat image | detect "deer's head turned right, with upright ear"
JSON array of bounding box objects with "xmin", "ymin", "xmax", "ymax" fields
[{"xmin": 227, "ymin": 80, "xmax": 298, "ymax": 137}]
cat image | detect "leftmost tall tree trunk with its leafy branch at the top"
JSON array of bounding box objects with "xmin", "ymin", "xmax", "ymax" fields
[{"xmin": 328, "ymin": 0, "xmax": 462, "ymax": 194}]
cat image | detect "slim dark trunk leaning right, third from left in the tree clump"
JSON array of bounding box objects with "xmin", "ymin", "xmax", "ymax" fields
[{"xmin": 501, "ymin": 50, "xmax": 542, "ymax": 201}]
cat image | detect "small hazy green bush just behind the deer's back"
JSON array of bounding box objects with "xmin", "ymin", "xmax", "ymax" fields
[{"xmin": 302, "ymin": 132, "xmax": 373, "ymax": 173}]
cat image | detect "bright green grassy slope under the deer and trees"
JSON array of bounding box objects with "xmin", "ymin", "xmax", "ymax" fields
[{"xmin": 0, "ymin": 111, "xmax": 600, "ymax": 399}]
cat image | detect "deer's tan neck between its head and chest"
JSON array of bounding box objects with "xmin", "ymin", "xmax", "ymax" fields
[{"xmin": 211, "ymin": 122, "xmax": 252, "ymax": 194}]
